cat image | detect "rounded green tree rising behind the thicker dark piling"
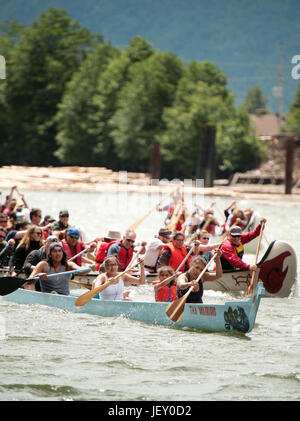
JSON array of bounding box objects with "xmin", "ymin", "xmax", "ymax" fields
[{"xmin": 159, "ymin": 62, "xmax": 233, "ymax": 178}]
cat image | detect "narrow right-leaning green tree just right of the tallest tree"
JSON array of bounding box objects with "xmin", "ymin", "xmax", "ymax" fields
[{"xmin": 55, "ymin": 43, "xmax": 120, "ymax": 165}]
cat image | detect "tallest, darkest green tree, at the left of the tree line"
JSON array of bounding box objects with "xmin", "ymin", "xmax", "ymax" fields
[{"xmin": 3, "ymin": 8, "xmax": 101, "ymax": 165}]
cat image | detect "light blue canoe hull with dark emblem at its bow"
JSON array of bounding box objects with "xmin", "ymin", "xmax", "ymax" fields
[{"xmin": 2, "ymin": 283, "xmax": 264, "ymax": 333}]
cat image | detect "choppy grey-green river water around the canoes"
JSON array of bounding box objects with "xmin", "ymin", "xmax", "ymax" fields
[{"xmin": 0, "ymin": 190, "xmax": 300, "ymax": 403}]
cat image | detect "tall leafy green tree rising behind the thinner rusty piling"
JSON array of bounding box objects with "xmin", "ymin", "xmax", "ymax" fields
[{"xmin": 111, "ymin": 51, "xmax": 183, "ymax": 171}]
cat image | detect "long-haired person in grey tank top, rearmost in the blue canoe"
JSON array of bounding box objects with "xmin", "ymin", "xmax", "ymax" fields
[{"xmin": 24, "ymin": 243, "xmax": 90, "ymax": 295}]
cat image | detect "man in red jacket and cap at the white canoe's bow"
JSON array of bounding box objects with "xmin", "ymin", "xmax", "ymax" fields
[{"xmin": 221, "ymin": 218, "xmax": 266, "ymax": 271}]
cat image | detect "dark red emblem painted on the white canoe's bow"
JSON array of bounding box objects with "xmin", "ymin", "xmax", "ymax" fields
[{"xmin": 259, "ymin": 251, "xmax": 291, "ymax": 294}]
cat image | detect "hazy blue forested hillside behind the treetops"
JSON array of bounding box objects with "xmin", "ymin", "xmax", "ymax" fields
[{"xmin": 0, "ymin": 0, "xmax": 300, "ymax": 112}]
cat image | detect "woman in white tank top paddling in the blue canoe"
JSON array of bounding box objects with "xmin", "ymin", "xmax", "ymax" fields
[{"xmin": 93, "ymin": 256, "xmax": 146, "ymax": 301}]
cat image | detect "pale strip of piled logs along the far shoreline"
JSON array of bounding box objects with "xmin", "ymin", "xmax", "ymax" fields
[{"xmin": 0, "ymin": 165, "xmax": 300, "ymax": 203}]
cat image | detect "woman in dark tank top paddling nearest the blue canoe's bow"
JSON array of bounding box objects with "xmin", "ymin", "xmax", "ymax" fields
[{"xmin": 177, "ymin": 250, "xmax": 223, "ymax": 303}]
